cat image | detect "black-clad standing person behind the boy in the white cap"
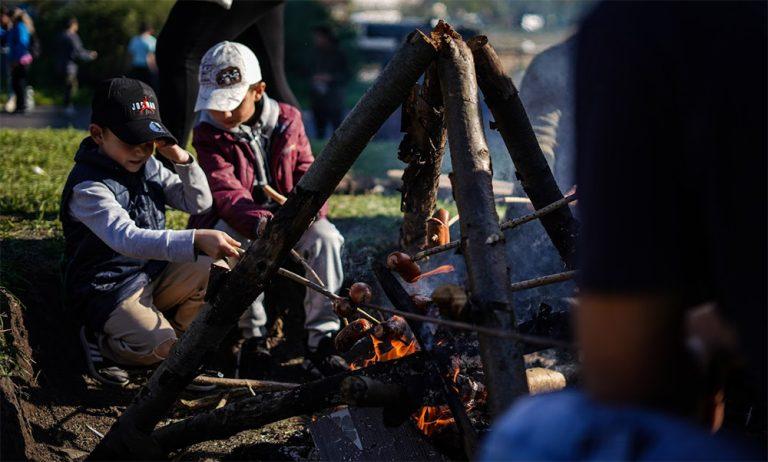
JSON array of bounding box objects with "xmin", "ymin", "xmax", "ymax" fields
[{"xmin": 157, "ymin": 0, "xmax": 299, "ymax": 147}]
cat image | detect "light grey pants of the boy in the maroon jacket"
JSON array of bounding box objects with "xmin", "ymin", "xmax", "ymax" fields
[{"xmin": 216, "ymin": 218, "xmax": 344, "ymax": 349}]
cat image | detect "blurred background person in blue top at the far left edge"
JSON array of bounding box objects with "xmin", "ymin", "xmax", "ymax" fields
[{"xmin": 8, "ymin": 8, "xmax": 35, "ymax": 114}]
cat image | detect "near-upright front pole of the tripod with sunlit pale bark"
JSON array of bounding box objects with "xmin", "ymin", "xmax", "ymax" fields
[{"xmin": 438, "ymin": 31, "xmax": 528, "ymax": 416}]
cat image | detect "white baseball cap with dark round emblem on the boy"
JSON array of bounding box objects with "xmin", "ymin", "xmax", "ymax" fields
[{"xmin": 195, "ymin": 41, "xmax": 261, "ymax": 112}]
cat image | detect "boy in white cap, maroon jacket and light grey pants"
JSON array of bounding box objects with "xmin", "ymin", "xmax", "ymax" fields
[{"xmin": 190, "ymin": 42, "xmax": 347, "ymax": 375}]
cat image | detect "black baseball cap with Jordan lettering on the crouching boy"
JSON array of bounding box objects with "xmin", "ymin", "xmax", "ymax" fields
[{"xmin": 91, "ymin": 77, "xmax": 178, "ymax": 144}]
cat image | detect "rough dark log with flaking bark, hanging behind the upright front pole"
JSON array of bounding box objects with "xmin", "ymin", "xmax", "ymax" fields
[{"xmin": 397, "ymin": 63, "xmax": 446, "ymax": 252}]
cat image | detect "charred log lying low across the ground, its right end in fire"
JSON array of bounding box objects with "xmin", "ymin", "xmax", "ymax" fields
[{"xmin": 152, "ymin": 353, "xmax": 442, "ymax": 455}]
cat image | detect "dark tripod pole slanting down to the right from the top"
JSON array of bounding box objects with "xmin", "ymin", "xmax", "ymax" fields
[{"xmin": 462, "ymin": 35, "xmax": 579, "ymax": 269}]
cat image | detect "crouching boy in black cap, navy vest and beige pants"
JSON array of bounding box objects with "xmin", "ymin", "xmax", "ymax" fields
[{"xmin": 60, "ymin": 78, "xmax": 239, "ymax": 386}]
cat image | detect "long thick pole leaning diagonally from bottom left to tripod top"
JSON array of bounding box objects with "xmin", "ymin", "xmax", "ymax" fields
[{"xmin": 90, "ymin": 31, "xmax": 436, "ymax": 459}]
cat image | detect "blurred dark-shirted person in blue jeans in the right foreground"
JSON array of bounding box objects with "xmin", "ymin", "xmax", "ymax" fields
[{"xmin": 482, "ymin": 2, "xmax": 768, "ymax": 460}]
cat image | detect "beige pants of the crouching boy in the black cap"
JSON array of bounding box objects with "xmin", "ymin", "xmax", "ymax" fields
[{"xmin": 99, "ymin": 256, "xmax": 212, "ymax": 366}]
